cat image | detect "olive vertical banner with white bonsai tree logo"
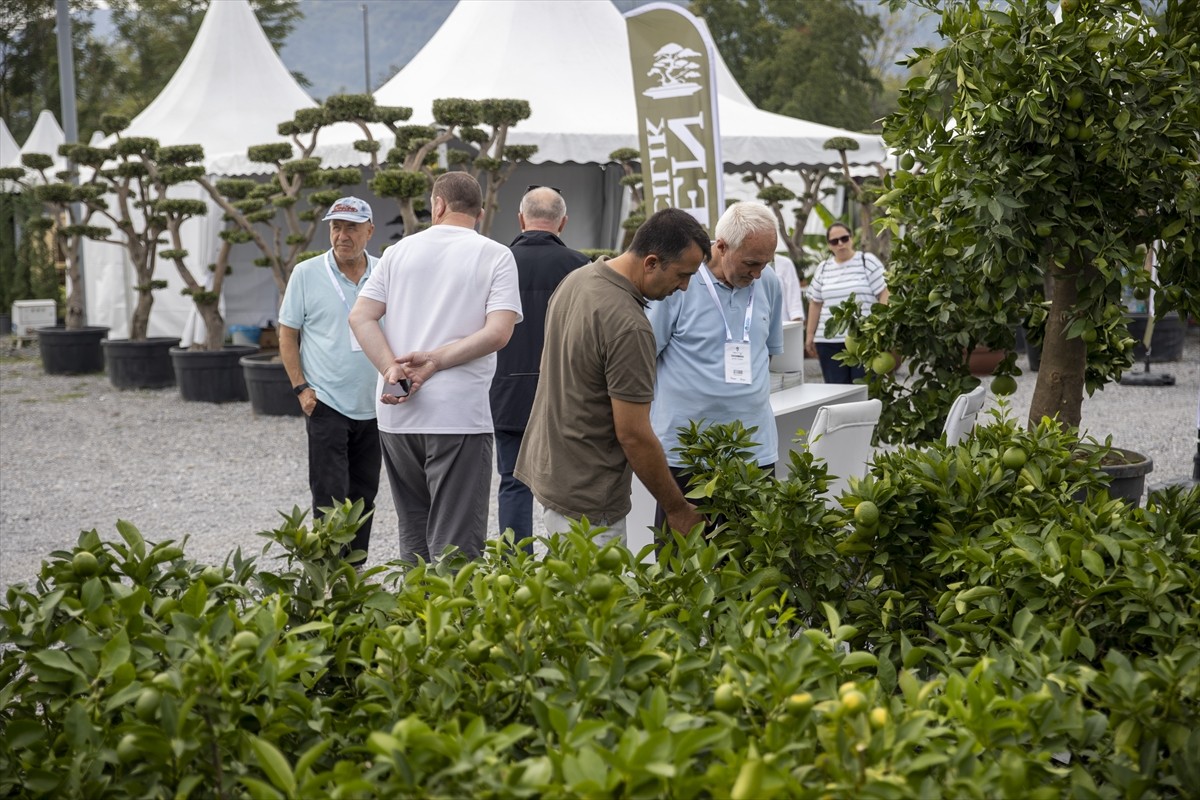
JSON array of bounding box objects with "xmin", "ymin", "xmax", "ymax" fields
[{"xmin": 625, "ymin": 2, "xmax": 725, "ymax": 234}]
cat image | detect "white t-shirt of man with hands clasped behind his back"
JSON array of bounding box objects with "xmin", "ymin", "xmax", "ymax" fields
[{"xmin": 359, "ymin": 224, "xmax": 521, "ymax": 434}]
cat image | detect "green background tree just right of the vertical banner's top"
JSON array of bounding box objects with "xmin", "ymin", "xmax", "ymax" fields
[{"xmin": 691, "ymin": 0, "xmax": 882, "ymax": 131}]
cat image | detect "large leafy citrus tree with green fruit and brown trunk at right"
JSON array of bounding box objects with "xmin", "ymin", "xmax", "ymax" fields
[{"xmin": 854, "ymin": 0, "xmax": 1200, "ymax": 440}]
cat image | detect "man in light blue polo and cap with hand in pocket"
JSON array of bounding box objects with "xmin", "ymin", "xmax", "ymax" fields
[{"xmin": 280, "ymin": 197, "xmax": 383, "ymax": 555}]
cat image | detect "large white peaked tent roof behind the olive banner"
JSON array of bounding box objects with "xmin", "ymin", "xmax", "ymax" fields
[{"xmin": 376, "ymin": 0, "xmax": 886, "ymax": 169}]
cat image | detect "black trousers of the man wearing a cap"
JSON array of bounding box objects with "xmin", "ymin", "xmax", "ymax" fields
[{"xmin": 305, "ymin": 401, "xmax": 383, "ymax": 561}]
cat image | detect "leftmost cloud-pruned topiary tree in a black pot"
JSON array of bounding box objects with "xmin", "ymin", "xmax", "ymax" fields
[{"xmin": 0, "ymin": 152, "xmax": 108, "ymax": 374}]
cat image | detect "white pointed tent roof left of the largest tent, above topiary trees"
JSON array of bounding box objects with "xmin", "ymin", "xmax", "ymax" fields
[{"xmin": 114, "ymin": 0, "xmax": 317, "ymax": 175}]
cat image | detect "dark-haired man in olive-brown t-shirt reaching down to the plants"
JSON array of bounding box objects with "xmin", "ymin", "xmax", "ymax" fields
[{"xmin": 514, "ymin": 209, "xmax": 710, "ymax": 540}]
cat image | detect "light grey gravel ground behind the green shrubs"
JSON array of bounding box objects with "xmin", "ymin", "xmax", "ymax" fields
[{"xmin": 0, "ymin": 327, "xmax": 1200, "ymax": 591}]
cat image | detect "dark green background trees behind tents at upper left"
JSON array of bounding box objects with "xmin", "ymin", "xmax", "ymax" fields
[{"xmin": 0, "ymin": 0, "xmax": 306, "ymax": 142}]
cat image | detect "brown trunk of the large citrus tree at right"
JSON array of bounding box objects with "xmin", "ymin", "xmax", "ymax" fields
[{"xmin": 1030, "ymin": 262, "xmax": 1096, "ymax": 427}]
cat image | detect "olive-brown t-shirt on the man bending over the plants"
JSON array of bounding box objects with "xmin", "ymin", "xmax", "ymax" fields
[{"xmin": 514, "ymin": 259, "xmax": 655, "ymax": 523}]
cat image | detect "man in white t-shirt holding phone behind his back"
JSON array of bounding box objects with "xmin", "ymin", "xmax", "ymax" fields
[{"xmin": 350, "ymin": 172, "xmax": 521, "ymax": 561}]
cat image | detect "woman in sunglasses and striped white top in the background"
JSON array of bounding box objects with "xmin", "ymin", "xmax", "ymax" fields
[{"xmin": 804, "ymin": 222, "xmax": 888, "ymax": 384}]
